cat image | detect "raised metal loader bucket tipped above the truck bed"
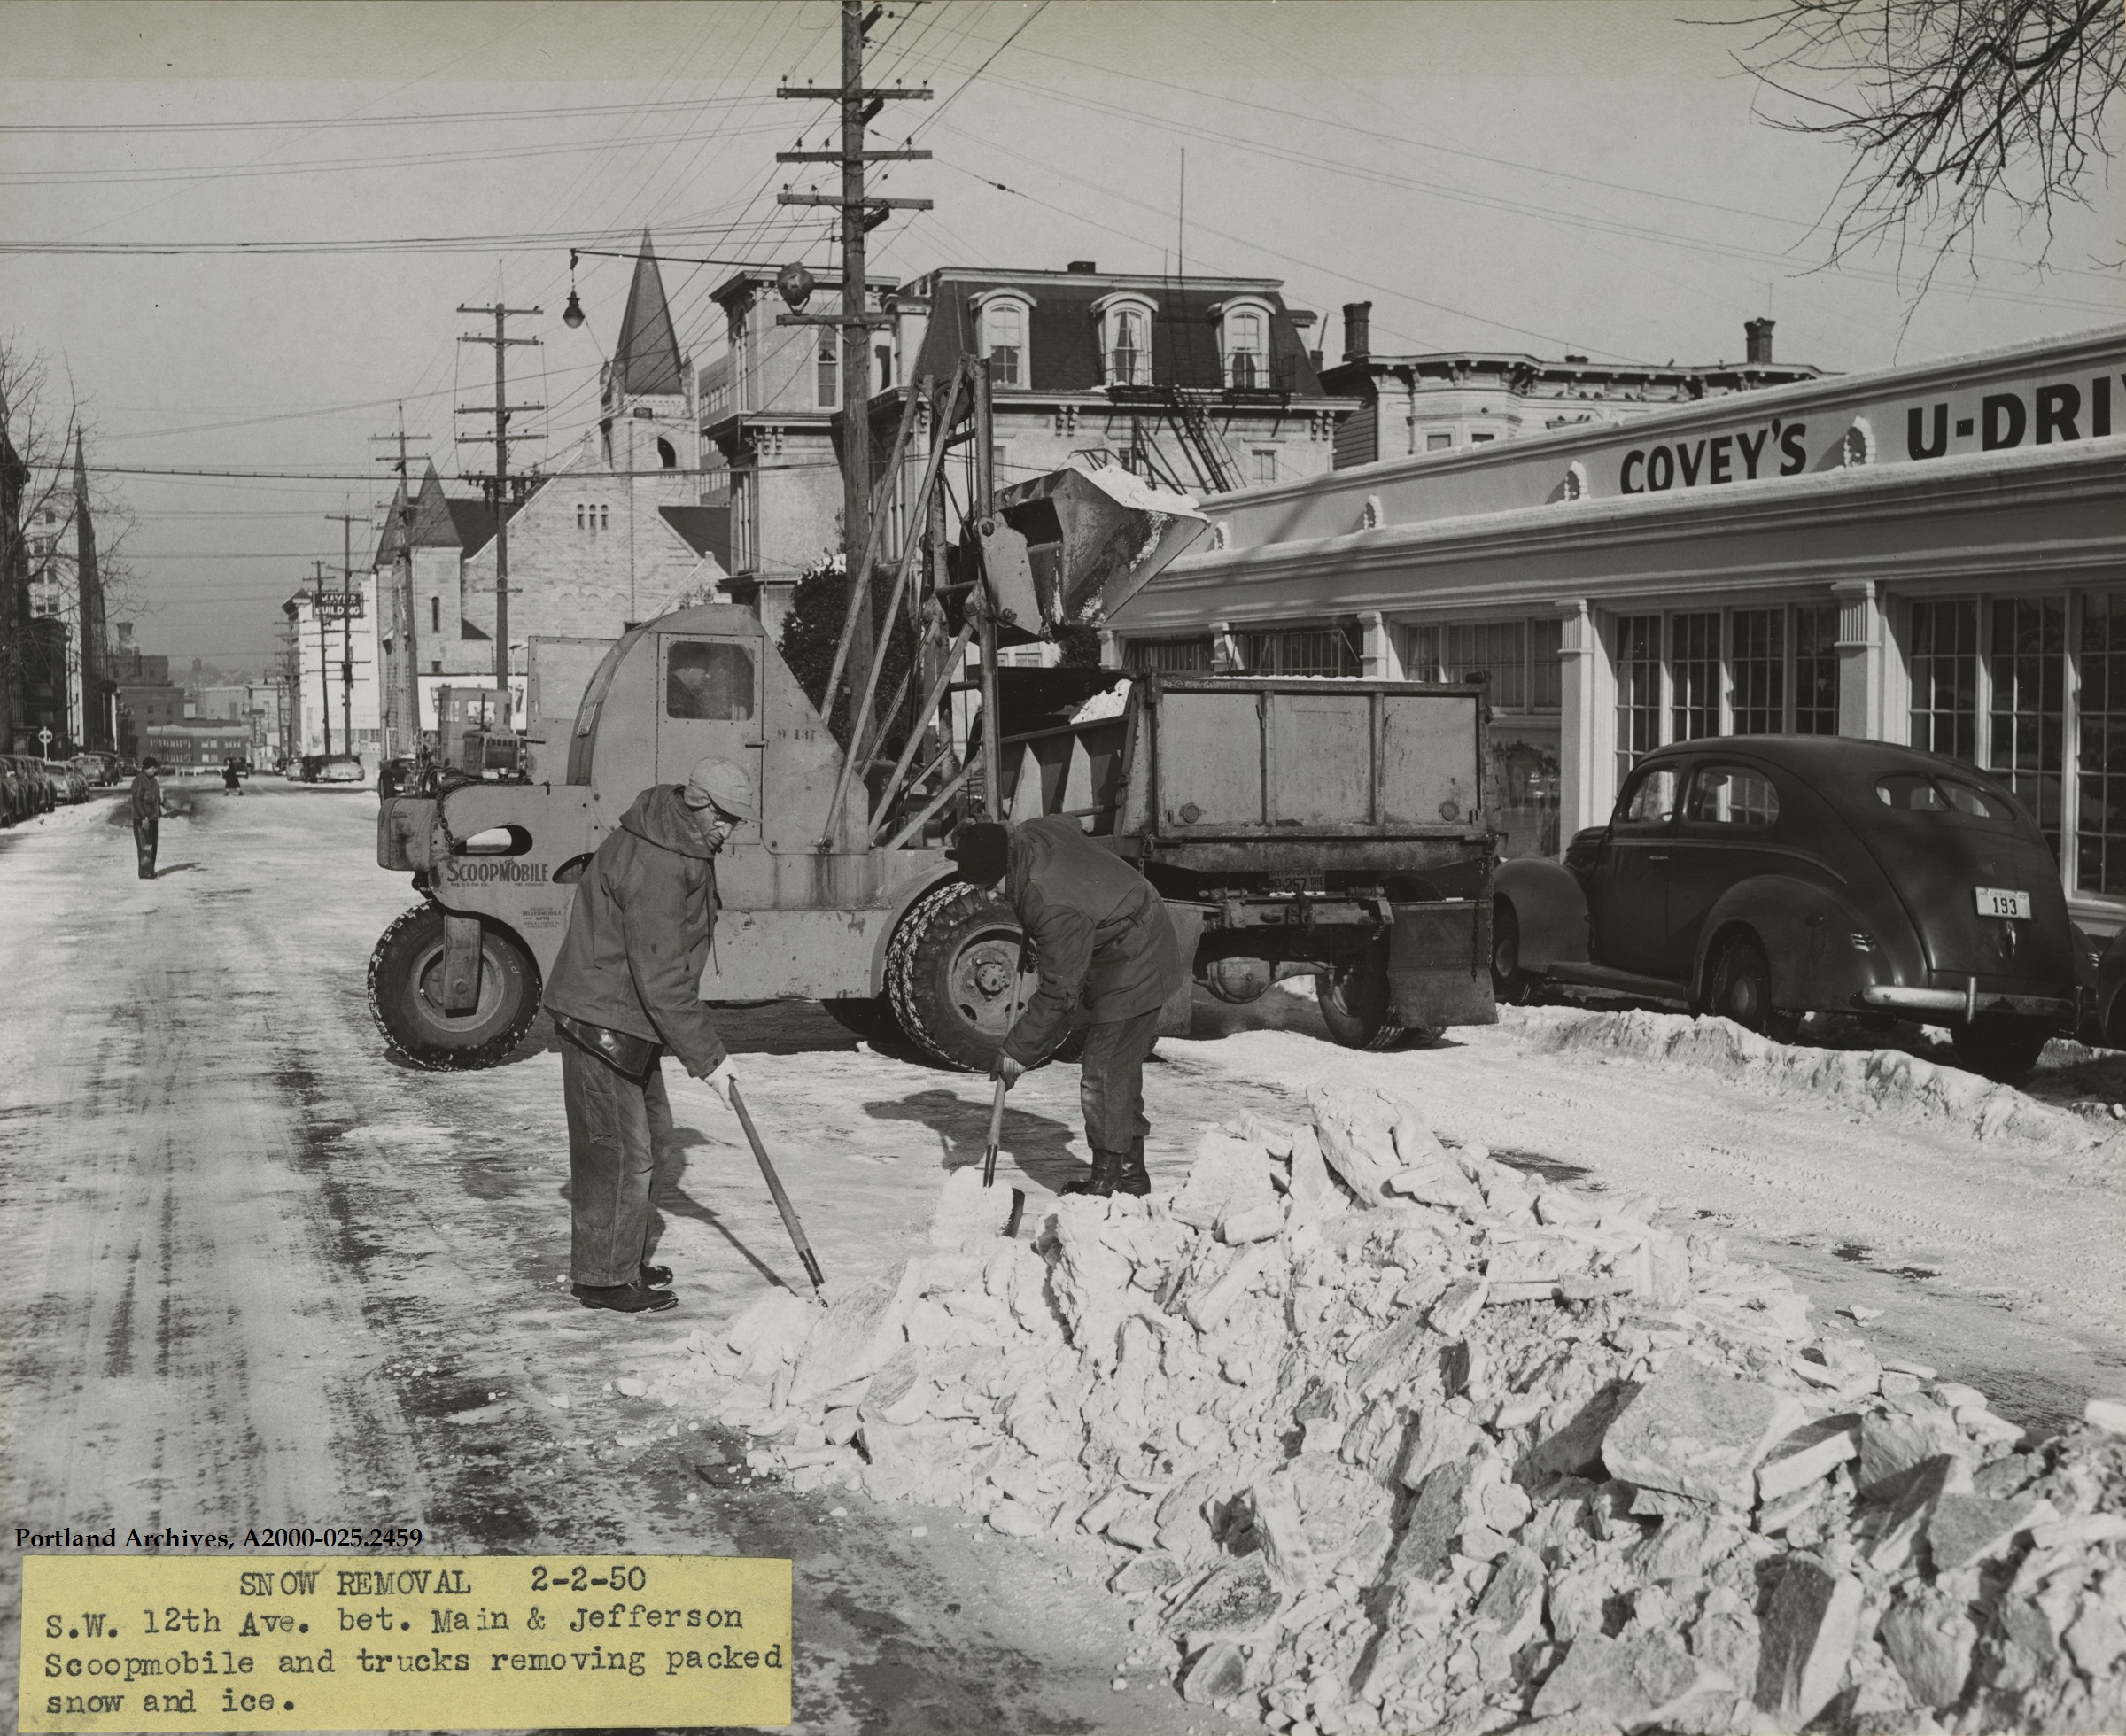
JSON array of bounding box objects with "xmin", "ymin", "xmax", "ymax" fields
[{"xmin": 990, "ymin": 465, "xmax": 1210, "ymax": 635}]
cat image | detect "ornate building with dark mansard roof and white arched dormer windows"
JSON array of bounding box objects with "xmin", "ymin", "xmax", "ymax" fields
[{"xmin": 702, "ymin": 261, "xmax": 1356, "ymax": 623}]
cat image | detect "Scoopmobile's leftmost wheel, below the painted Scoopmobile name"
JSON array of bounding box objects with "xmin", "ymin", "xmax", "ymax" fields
[{"xmin": 370, "ymin": 903, "xmax": 540, "ymax": 1073}]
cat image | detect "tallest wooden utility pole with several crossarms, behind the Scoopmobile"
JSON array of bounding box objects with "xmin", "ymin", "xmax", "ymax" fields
[{"xmin": 776, "ymin": 0, "xmax": 931, "ymax": 705}]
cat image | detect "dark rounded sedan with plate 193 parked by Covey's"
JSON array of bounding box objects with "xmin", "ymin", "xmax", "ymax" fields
[{"xmin": 1493, "ymin": 735, "xmax": 2082, "ymax": 1080}]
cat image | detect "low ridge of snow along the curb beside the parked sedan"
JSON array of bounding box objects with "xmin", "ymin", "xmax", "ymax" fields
[{"xmin": 1518, "ymin": 1007, "xmax": 2090, "ymax": 1147}]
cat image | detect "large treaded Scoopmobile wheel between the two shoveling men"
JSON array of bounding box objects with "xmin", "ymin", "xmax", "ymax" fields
[{"xmin": 887, "ymin": 880, "xmax": 1036, "ymax": 1073}]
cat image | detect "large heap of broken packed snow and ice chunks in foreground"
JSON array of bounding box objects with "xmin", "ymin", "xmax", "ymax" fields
[{"xmin": 695, "ymin": 1090, "xmax": 2126, "ymax": 1736}]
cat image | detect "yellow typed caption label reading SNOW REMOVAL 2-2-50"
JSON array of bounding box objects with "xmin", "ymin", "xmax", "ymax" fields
[{"xmin": 19, "ymin": 1555, "xmax": 791, "ymax": 1732}]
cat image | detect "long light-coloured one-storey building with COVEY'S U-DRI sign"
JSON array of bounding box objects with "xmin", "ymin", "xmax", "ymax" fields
[{"xmin": 1110, "ymin": 327, "xmax": 2126, "ymax": 931}]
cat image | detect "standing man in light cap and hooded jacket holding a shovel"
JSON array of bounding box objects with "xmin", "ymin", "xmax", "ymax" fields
[{"xmin": 547, "ymin": 758, "xmax": 759, "ymax": 1314}]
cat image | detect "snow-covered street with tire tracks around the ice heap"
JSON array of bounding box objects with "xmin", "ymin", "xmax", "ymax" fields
[{"xmin": 0, "ymin": 778, "xmax": 2126, "ymax": 1732}]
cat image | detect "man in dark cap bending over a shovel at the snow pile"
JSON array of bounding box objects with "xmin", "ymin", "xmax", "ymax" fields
[{"xmin": 952, "ymin": 814, "xmax": 1184, "ymax": 1194}]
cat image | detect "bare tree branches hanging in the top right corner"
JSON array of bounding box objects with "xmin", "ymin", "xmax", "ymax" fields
[{"xmin": 1734, "ymin": 0, "xmax": 2126, "ymax": 274}]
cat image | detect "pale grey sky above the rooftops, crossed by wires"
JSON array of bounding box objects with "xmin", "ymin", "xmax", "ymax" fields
[{"xmin": 0, "ymin": 0, "xmax": 2126, "ymax": 663}]
